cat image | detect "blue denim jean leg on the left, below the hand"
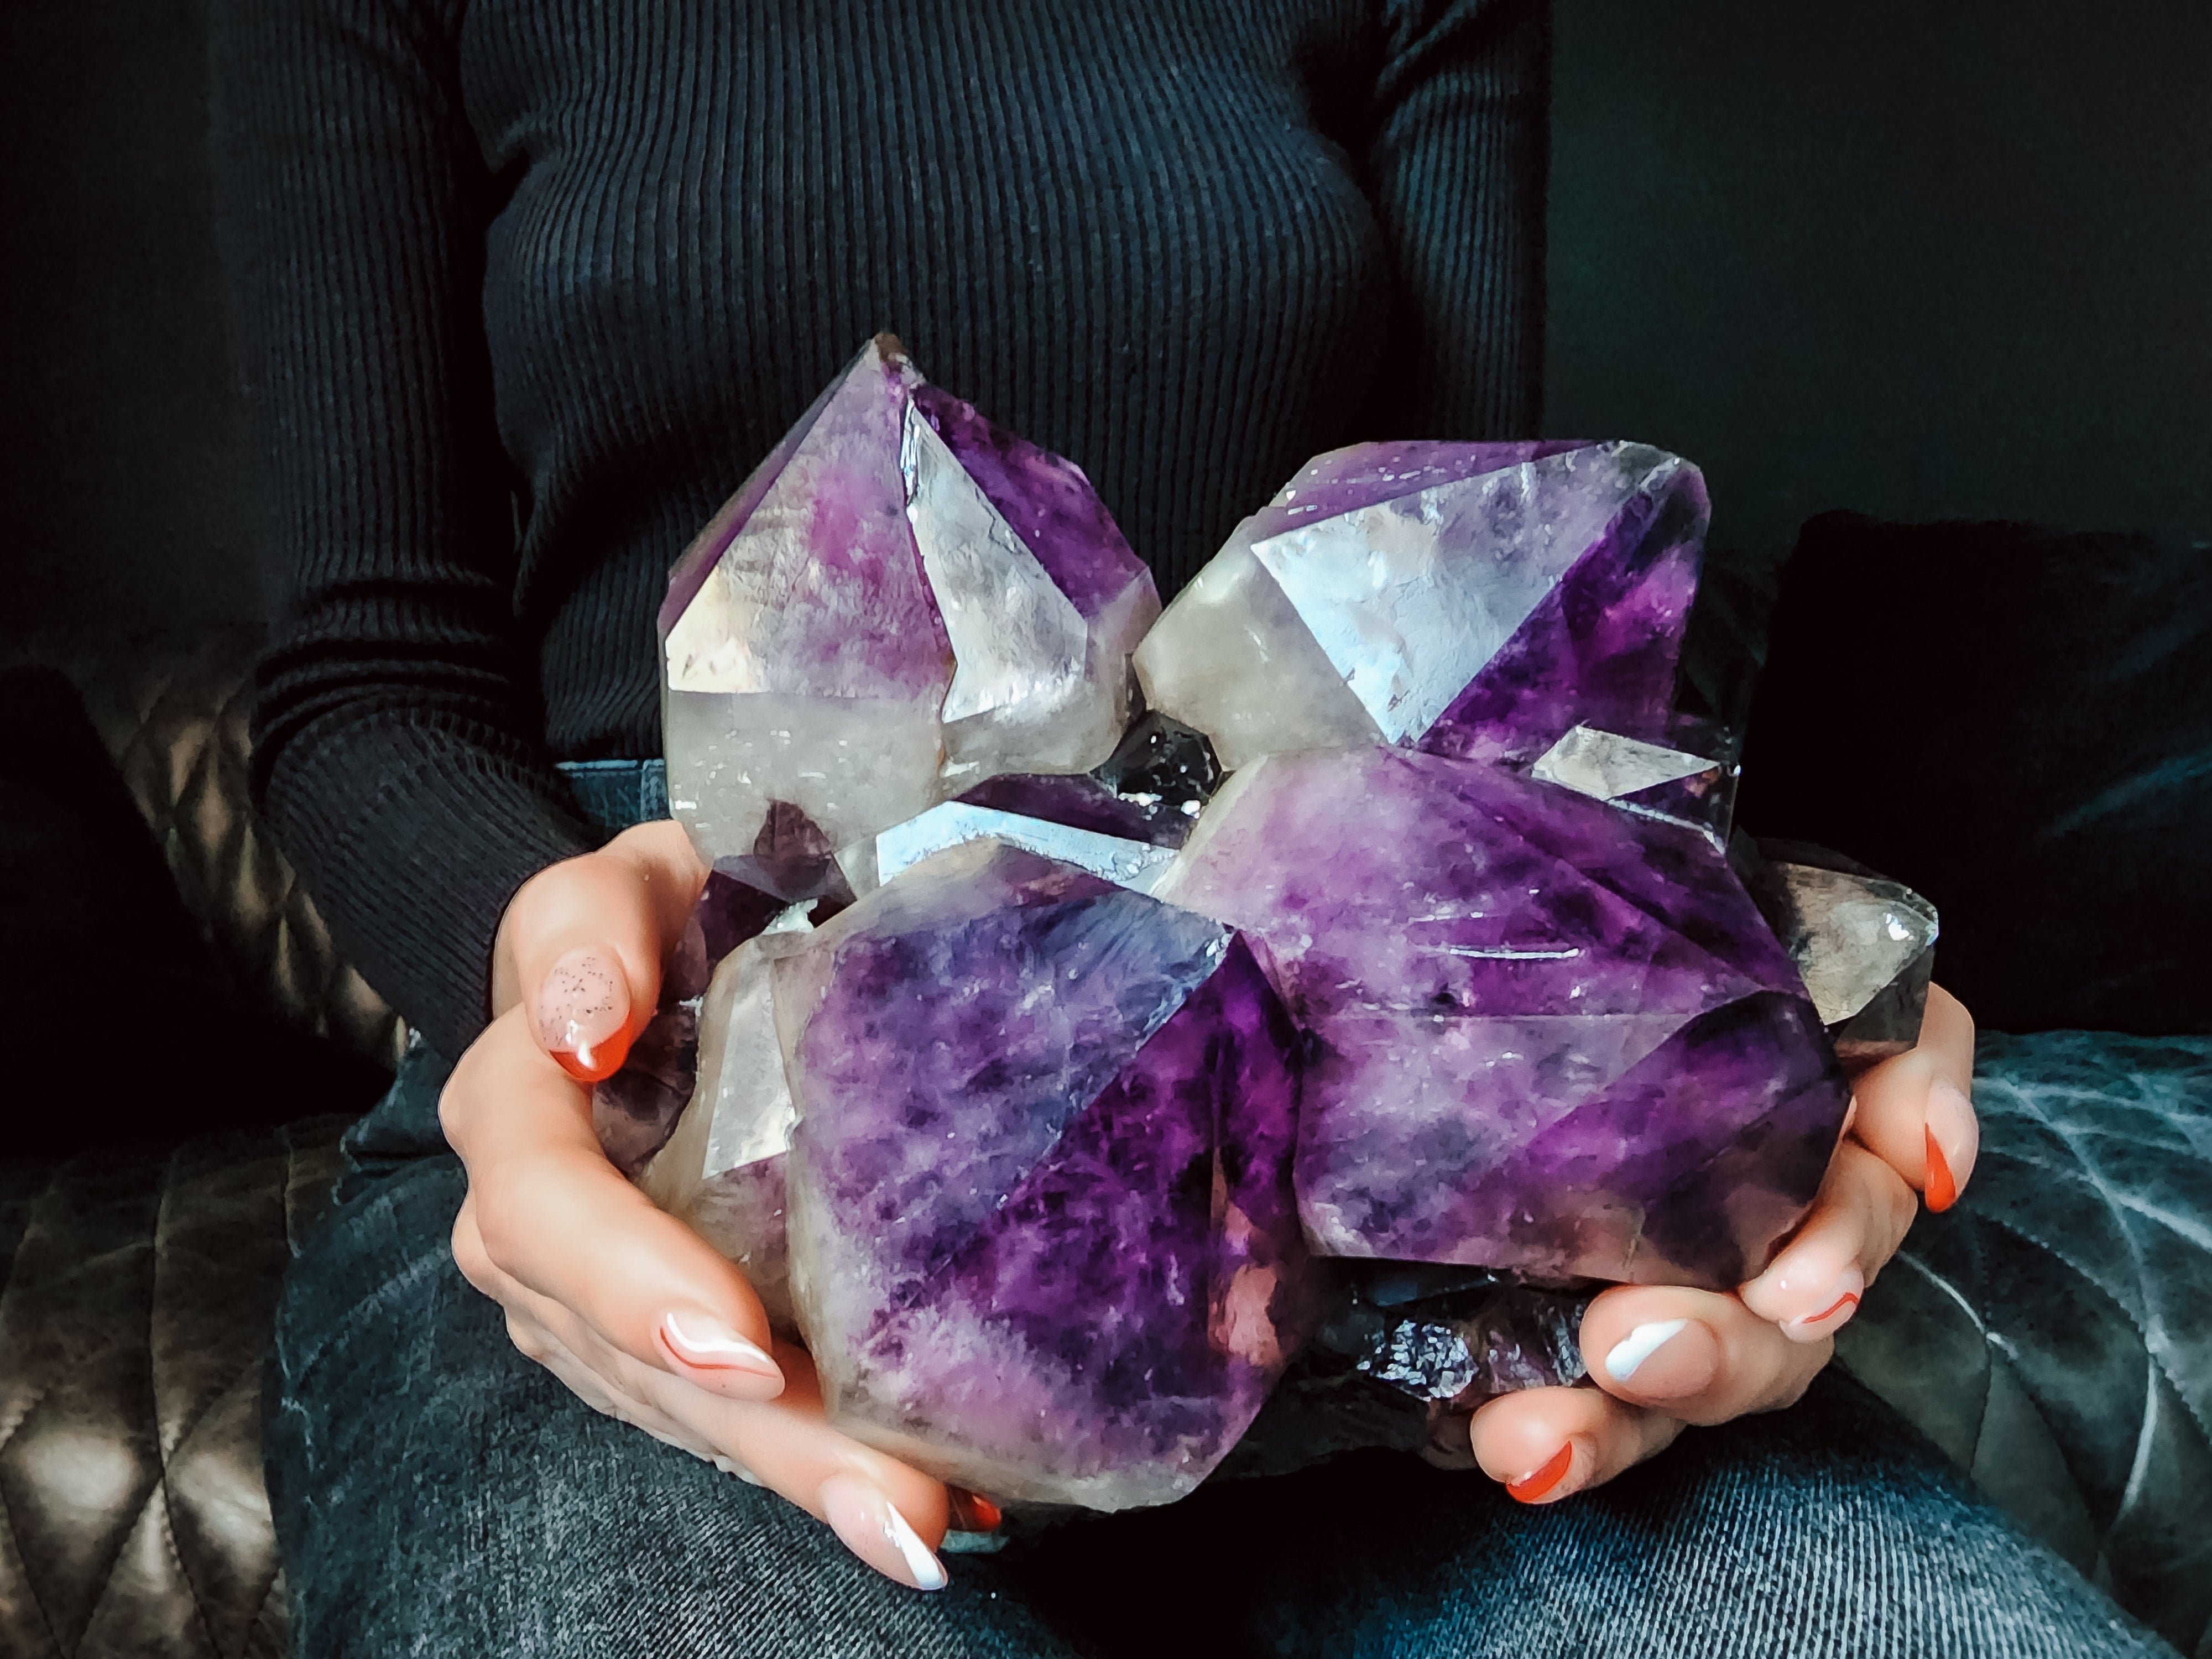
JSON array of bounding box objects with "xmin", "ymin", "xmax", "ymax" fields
[{"xmin": 268, "ymin": 1157, "xmax": 1066, "ymax": 1659}]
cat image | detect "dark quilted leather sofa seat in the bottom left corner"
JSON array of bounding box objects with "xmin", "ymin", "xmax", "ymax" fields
[{"xmin": 0, "ymin": 1117, "xmax": 345, "ymax": 1659}]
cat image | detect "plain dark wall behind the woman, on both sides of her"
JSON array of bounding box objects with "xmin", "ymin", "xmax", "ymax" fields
[{"xmin": 0, "ymin": 0, "xmax": 2212, "ymax": 644}]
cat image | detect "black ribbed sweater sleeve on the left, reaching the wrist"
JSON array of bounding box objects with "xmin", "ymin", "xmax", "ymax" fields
[{"xmin": 210, "ymin": 0, "xmax": 593, "ymax": 1055}]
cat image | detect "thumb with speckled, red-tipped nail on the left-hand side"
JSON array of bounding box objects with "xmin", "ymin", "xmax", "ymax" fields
[{"xmin": 493, "ymin": 823, "xmax": 706, "ymax": 1084}]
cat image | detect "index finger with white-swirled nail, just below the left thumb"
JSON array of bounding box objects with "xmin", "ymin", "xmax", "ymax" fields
[{"xmin": 440, "ymin": 1006, "xmax": 783, "ymax": 1400}]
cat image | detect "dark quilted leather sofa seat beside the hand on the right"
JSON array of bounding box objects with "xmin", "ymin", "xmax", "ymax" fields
[{"xmin": 1836, "ymin": 1031, "xmax": 2212, "ymax": 1659}]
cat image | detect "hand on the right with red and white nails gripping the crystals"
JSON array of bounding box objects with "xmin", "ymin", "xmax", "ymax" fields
[{"xmin": 1471, "ymin": 987, "xmax": 1980, "ymax": 1504}]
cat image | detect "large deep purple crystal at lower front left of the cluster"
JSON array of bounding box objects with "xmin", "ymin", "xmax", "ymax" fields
[{"xmin": 776, "ymin": 843, "xmax": 1303, "ymax": 1509}]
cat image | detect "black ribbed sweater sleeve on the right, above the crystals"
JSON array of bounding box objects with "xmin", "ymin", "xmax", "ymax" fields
[{"xmin": 1365, "ymin": 0, "xmax": 1551, "ymax": 438}]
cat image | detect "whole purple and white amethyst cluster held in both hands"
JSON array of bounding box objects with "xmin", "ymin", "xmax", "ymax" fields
[{"xmin": 602, "ymin": 338, "xmax": 1936, "ymax": 1509}]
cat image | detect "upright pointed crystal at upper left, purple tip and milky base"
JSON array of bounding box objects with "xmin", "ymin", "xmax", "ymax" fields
[{"xmin": 661, "ymin": 336, "xmax": 1159, "ymax": 898}]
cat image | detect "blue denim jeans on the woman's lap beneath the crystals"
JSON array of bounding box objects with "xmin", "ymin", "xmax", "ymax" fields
[{"xmin": 268, "ymin": 770, "xmax": 2170, "ymax": 1659}]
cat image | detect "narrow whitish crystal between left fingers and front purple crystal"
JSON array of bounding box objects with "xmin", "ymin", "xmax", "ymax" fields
[{"xmin": 637, "ymin": 929, "xmax": 803, "ymax": 1329}]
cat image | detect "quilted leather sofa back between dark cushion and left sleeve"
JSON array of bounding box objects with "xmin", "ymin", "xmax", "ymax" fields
[{"xmin": 40, "ymin": 630, "xmax": 405, "ymax": 1068}]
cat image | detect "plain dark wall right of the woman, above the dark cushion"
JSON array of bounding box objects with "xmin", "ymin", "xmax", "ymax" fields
[{"xmin": 1548, "ymin": 0, "xmax": 2212, "ymax": 553}]
